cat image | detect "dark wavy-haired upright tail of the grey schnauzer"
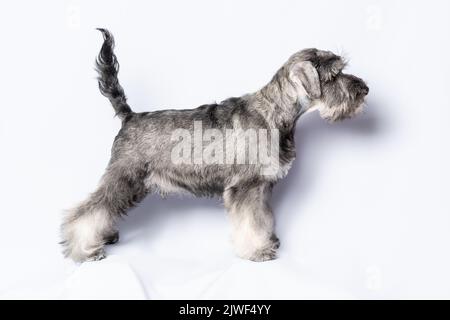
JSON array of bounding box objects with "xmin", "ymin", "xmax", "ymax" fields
[{"xmin": 95, "ymin": 28, "xmax": 132, "ymax": 120}]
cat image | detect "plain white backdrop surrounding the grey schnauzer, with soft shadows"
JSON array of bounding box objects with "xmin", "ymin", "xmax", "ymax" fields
[{"xmin": 0, "ymin": 0, "xmax": 450, "ymax": 299}]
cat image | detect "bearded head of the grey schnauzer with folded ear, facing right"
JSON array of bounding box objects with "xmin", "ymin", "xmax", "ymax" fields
[{"xmin": 286, "ymin": 49, "xmax": 369, "ymax": 122}]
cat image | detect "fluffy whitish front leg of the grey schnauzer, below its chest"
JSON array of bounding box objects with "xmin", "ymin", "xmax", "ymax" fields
[{"xmin": 223, "ymin": 182, "xmax": 280, "ymax": 261}]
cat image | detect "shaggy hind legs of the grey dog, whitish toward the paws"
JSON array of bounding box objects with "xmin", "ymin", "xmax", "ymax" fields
[{"xmin": 62, "ymin": 164, "xmax": 147, "ymax": 262}]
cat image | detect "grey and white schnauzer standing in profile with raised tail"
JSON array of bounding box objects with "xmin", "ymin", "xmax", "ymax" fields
[{"xmin": 62, "ymin": 29, "xmax": 369, "ymax": 261}]
